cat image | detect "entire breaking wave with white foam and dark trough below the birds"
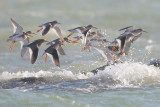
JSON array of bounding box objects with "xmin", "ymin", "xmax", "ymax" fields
[{"xmin": 0, "ymin": 62, "xmax": 160, "ymax": 92}]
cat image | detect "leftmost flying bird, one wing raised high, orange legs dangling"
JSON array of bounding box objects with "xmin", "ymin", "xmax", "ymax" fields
[{"xmin": 7, "ymin": 18, "xmax": 35, "ymax": 57}]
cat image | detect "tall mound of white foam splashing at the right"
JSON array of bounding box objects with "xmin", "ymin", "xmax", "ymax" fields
[{"xmin": 91, "ymin": 62, "xmax": 160, "ymax": 86}]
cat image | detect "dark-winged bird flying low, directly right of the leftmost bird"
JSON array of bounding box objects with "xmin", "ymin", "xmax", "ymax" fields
[{"xmin": 23, "ymin": 39, "xmax": 48, "ymax": 64}]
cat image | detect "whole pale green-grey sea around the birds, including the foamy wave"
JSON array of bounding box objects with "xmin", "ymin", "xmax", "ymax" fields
[{"xmin": 0, "ymin": 0, "xmax": 160, "ymax": 107}]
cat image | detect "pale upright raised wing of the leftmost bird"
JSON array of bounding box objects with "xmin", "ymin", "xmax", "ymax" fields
[{"xmin": 11, "ymin": 18, "xmax": 23, "ymax": 34}]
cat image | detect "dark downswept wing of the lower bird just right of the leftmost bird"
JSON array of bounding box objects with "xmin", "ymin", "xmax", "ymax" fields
[{"xmin": 29, "ymin": 46, "xmax": 39, "ymax": 64}]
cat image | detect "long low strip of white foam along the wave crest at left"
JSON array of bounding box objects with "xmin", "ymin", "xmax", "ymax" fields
[{"xmin": 0, "ymin": 70, "xmax": 88, "ymax": 82}]
